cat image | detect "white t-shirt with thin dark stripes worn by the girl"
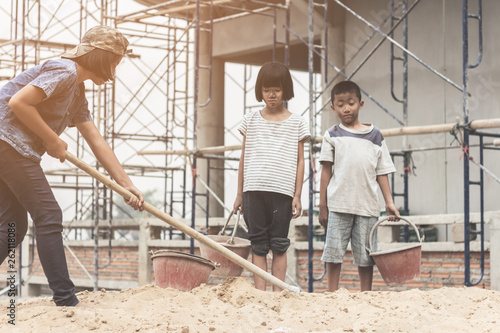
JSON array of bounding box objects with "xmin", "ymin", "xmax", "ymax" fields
[{"xmin": 238, "ymin": 111, "xmax": 311, "ymax": 198}]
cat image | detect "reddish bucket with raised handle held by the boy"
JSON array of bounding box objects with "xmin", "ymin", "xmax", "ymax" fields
[{"xmin": 368, "ymin": 217, "xmax": 422, "ymax": 286}]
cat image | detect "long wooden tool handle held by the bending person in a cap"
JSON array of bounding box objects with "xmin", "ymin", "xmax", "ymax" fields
[{"xmin": 66, "ymin": 152, "xmax": 300, "ymax": 294}]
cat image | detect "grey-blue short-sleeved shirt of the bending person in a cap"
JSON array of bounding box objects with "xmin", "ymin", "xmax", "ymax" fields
[{"xmin": 0, "ymin": 59, "xmax": 92, "ymax": 162}]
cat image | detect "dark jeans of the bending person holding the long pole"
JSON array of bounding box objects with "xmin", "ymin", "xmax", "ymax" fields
[{"xmin": 0, "ymin": 140, "xmax": 78, "ymax": 306}]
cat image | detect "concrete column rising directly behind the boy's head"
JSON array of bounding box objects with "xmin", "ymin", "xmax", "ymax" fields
[{"xmin": 321, "ymin": 3, "xmax": 345, "ymax": 135}]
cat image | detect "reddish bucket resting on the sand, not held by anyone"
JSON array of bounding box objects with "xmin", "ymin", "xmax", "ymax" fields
[{"xmin": 150, "ymin": 250, "xmax": 216, "ymax": 291}]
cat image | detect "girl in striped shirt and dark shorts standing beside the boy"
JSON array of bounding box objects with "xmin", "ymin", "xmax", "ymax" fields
[{"xmin": 233, "ymin": 61, "xmax": 311, "ymax": 291}]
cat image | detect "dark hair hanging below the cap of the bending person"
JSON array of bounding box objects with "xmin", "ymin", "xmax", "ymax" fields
[{"xmin": 71, "ymin": 48, "xmax": 122, "ymax": 81}]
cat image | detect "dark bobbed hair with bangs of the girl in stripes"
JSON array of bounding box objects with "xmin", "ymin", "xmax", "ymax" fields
[{"xmin": 255, "ymin": 61, "xmax": 294, "ymax": 102}]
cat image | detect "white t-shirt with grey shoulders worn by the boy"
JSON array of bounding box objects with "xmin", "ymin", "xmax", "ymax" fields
[{"xmin": 319, "ymin": 124, "xmax": 396, "ymax": 217}]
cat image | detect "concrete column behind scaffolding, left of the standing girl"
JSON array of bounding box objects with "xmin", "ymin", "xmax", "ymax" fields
[{"xmin": 196, "ymin": 7, "xmax": 224, "ymax": 217}]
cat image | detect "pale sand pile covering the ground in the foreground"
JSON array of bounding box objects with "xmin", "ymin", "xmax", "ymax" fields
[{"xmin": 0, "ymin": 278, "xmax": 500, "ymax": 333}]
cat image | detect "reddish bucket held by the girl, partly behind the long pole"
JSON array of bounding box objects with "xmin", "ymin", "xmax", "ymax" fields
[{"xmin": 200, "ymin": 235, "xmax": 251, "ymax": 278}]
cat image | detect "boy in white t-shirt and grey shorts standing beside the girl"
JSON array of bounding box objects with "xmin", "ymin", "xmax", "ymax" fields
[{"xmin": 319, "ymin": 81, "xmax": 399, "ymax": 291}]
